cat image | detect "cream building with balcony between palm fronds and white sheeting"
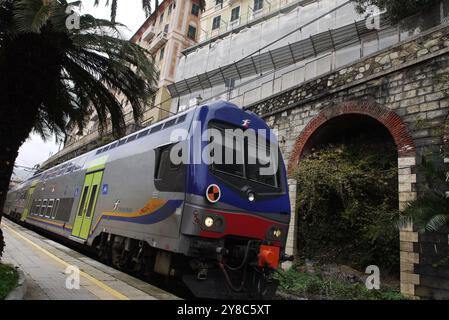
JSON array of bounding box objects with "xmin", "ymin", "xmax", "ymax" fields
[{"xmin": 42, "ymin": 0, "xmax": 201, "ymax": 168}]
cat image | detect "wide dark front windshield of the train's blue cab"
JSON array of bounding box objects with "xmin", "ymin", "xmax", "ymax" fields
[{"xmin": 209, "ymin": 122, "xmax": 279, "ymax": 189}]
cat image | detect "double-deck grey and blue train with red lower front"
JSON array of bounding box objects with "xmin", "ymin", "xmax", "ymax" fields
[{"xmin": 3, "ymin": 101, "xmax": 291, "ymax": 299}]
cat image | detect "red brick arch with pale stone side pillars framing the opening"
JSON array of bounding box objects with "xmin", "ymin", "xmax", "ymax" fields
[{"xmin": 287, "ymin": 102, "xmax": 416, "ymax": 292}]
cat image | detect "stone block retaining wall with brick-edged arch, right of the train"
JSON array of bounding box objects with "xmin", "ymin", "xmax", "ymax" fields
[{"xmin": 246, "ymin": 26, "xmax": 449, "ymax": 298}]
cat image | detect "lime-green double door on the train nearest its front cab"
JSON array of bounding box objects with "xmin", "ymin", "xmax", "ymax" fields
[{"xmin": 72, "ymin": 171, "xmax": 103, "ymax": 239}]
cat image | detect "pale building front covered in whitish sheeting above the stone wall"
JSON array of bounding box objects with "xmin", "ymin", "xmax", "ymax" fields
[{"xmin": 169, "ymin": 0, "xmax": 372, "ymax": 112}]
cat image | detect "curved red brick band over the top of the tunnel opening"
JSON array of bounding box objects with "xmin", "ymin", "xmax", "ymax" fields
[{"xmin": 288, "ymin": 102, "xmax": 414, "ymax": 173}]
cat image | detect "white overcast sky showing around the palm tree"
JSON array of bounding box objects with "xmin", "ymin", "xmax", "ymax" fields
[{"xmin": 13, "ymin": 0, "xmax": 149, "ymax": 179}]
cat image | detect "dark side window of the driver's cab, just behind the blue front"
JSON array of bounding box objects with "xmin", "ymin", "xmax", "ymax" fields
[{"xmin": 154, "ymin": 144, "xmax": 185, "ymax": 192}]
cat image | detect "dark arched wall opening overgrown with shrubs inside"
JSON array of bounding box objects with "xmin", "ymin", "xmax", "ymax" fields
[{"xmin": 295, "ymin": 114, "xmax": 399, "ymax": 282}]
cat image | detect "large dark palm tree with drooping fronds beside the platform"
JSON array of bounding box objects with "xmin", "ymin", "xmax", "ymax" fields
[{"xmin": 0, "ymin": 0, "xmax": 157, "ymax": 214}]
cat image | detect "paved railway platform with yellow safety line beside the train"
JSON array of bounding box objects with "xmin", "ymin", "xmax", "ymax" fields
[{"xmin": 1, "ymin": 218, "xmax": 178, "ymax": 300}]
